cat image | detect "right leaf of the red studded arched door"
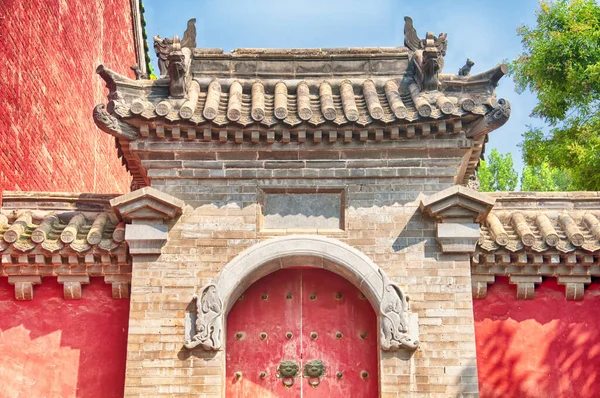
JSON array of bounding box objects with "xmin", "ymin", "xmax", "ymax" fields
[{"xmin": 302, "ymin": 269, "xmax": 379, "ymax": 398}]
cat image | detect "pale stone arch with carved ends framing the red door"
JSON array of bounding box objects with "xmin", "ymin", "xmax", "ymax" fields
[{"xmin": 185, "ymin": 235, "xmax": 418, "ymax": 351}]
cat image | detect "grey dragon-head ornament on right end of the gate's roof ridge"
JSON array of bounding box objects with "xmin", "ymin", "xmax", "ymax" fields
[{"xmin": 404, "ymin": 17, "xmax": 448, "ymax": 91}]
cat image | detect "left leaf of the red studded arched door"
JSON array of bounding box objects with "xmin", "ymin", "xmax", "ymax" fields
[{"xmin": 226, "ymin": 269, "xmax": 302, "ymax": 398}]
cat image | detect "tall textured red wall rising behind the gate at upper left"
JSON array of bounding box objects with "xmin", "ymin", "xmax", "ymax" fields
[{"xmin": 0, "ymin": 0, "xmax": 136, "ymax": 193}]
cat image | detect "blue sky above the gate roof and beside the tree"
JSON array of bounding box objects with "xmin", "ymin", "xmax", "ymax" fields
[{"xmin": 144, "ymin": 0, "xmax": 542, "ymax": 173}]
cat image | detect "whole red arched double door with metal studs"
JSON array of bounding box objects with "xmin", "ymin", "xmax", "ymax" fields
[{"xmin": 226, "ymin": 268, "xmax": 379, "ymax": 398}]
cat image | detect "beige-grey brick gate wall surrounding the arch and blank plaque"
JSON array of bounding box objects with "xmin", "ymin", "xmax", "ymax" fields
[{"xmin": 125, "ymin": 141, "xmax": 478, "ymax": 397}]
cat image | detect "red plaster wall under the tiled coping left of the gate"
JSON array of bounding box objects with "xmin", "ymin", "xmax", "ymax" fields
[{"xmin": 0, "ymin": 278, "xmax": 129, "ymax": 398}]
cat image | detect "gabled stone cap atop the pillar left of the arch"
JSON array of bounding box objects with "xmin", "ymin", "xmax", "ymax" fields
[{"xmin": 110, "ymin": 187, "xmax": 184, "ymax": 221}]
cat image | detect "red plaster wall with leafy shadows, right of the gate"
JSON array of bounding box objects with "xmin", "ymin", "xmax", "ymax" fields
[{"xmin": 473, "ymin": 278, "xmax": 600, "ymax": 398}]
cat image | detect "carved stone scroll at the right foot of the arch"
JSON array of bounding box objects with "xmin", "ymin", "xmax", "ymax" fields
[{"xmin": 379, "ymin": 270, "xmax": 419, "ymax": 351}]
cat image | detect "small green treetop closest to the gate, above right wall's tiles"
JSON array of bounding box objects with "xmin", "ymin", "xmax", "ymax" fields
[{"xmin": 477, "ymin": 148, "xmax": 519, "ymax": 192}]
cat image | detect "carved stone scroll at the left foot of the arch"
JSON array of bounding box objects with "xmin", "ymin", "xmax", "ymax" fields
[{"xmin": 185, "ymin": 284, "xmax": 223, "ymax": 351}]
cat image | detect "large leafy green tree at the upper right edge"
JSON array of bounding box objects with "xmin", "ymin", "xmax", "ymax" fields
[{"xmin": 511, "ymin": 0, "xmax": 600, "ymax": 190}]
